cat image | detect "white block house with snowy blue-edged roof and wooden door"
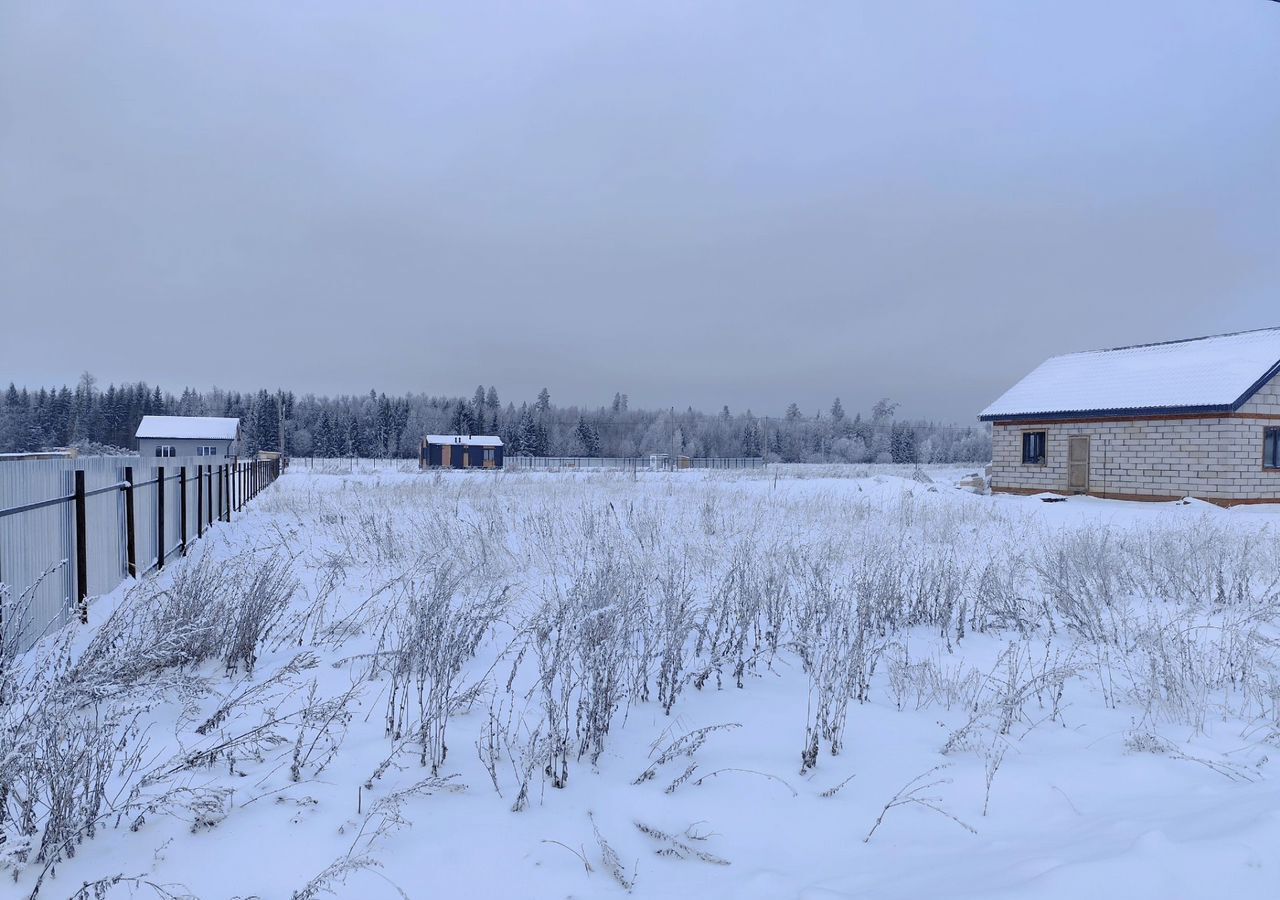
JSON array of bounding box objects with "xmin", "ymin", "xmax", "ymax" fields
[{"xmin": 979, "ymin": 328, "xmax": 1280, "ymax": 506}]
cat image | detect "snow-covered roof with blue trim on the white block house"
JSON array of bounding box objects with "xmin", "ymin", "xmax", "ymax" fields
[{"xmin": 979, "ymin": 328, "xmax": 1280, "ymax": 420}]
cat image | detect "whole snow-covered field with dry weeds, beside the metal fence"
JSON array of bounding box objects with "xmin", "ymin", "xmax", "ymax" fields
[{"xmin": 0, "ymin": 462, "xmax": 1280, "ymax": 900}]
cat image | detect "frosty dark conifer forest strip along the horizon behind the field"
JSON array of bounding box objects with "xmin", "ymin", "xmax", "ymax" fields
[{"xmin": 0, "ymin": 373, "xmax": 991, "ymax": 463}]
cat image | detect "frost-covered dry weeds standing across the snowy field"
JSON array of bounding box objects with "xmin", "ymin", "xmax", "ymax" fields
[{"xmin": 0, "ymin": 467, "xmax": 1280, "ymax": 897}]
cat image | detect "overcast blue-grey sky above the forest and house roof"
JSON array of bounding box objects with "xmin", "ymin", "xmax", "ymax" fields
[{"xmin": 0, "ymin": 0, "xmax": 1280, "ymax": 421}]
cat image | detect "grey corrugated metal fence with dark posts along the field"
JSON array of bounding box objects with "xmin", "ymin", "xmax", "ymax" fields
[{"xmin": 0, "ymin": 456, "xmax": 285, "ymax": 653}]
